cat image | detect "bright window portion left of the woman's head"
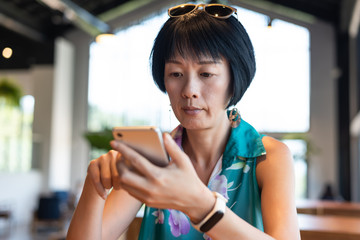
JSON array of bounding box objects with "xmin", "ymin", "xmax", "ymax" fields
[{"xmin": 89, "ymin": 14, "xmax": 172, "ymax": 131}]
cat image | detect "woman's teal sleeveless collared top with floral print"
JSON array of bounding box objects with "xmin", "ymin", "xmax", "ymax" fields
[{"xmin": 139, "ymin": 119, "xmax": 266, "ymax": 240}]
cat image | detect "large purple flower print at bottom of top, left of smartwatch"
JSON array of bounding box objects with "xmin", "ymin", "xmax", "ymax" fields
[{"xmin": 169, "ymin": 209, "xmax": 190, "ymax": 237}]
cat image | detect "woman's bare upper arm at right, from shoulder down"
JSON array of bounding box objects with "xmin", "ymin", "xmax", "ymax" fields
[{"xmin": 256, "ymin": 137, "xmax": 300, "ymax": 239}]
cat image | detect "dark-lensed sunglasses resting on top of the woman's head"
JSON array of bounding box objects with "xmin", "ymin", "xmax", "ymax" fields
[{"xmin": 168, "ymin": 4, "xmax": 237, "ymax": 19}]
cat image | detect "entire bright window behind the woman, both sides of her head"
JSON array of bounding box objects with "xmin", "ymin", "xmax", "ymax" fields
[{"xmin": 89, "ymin": 8, "xmax": 310, "ymax": 197}]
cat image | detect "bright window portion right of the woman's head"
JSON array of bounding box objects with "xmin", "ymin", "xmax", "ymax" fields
[{"xmin": 238, "ymin": 10, "xmax": 310, "ymax": 132}]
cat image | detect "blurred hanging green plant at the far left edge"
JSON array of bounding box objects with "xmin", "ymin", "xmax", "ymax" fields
[{"xmin": 0, "ymin": 78, "xmax": 23, "ymax": 107}]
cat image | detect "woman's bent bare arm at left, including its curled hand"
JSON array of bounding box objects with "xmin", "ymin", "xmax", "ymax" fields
[{"xmin": 67, "ymin": 151, "xmax": 141, "ymax": 240}]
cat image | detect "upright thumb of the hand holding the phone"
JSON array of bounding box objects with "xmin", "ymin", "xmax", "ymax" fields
[{"xmin": 163, "ymin": 133, "xmax": 191, "ymax": 167}]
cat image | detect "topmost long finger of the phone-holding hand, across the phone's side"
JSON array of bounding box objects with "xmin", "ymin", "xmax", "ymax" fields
[{"xmin": 111, "ymin": 141, "xmax": 159, "ymax": 177}]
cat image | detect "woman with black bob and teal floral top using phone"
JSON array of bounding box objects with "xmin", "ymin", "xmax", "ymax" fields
[{"xmin": 68, "ymin": 4, "xmax": 300, "ymax": 239}]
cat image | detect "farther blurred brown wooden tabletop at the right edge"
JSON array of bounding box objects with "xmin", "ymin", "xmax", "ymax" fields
[{"xmin": 296, "ymin": 200, "xmax": 360, "ymax": 217}]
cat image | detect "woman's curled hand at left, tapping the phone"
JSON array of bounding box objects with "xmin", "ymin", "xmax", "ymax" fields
[{"xmin": 88, "ymin": 150, "xmax": 121, "ymax": 200}]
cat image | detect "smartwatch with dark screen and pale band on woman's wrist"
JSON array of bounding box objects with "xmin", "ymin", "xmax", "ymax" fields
[{"xmin": 192, "ymin": 192, "xmax": 227, "ymax": 232}]
